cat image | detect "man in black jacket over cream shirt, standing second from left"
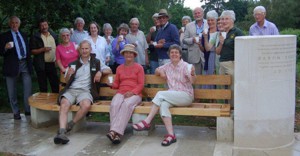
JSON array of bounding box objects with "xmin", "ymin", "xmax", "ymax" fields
[{"xmin": 30, "ymin": 19, "xmax": 59, "ymax": 93}]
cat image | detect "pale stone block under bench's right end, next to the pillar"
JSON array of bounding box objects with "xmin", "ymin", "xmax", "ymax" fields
[{"xmin": 217, "ymin": 114, "xmax": 233, "ymax": 142}]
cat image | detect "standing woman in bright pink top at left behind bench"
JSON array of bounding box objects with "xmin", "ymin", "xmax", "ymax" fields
[{"xmin": 55, "ymin": 28, "xmax": 79, "ymax": 73}]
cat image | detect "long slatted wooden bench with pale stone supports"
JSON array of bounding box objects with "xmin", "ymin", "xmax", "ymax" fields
[{"xmin": 29, "ymin": 75, "xmax": 233, "ymax": 140}]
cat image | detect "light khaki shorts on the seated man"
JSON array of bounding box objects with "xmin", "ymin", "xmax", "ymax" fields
[{"xmin": 59, "ymin": 88, "xmax": 93, "ymax": 105}]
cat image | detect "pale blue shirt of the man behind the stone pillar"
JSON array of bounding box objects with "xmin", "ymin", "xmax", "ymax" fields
[{"xmin": 249, "ymin": 20, "xmax": 279, "ymax": 36}]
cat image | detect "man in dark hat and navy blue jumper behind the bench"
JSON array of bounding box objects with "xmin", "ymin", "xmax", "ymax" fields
[{"xmin": 154, "ymin": 9, "xmax": 180, "ymax": 66}]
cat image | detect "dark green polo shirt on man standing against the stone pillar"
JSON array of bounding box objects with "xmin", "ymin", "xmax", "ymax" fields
[{"xmin": 220, "ymin": 27, "xmax": 244, "ymax": 62}]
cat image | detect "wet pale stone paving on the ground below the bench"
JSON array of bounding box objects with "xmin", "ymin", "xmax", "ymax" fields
[{"xmin": 0, "ymin": 113, "xmax": 300, "ymax": 156}]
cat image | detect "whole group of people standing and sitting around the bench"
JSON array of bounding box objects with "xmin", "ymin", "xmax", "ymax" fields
[{"xmin": 0, "ymin": 6, "xmax": 279, "ymax": 146}]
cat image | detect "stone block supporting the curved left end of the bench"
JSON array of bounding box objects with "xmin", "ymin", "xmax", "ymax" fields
[{"xmin": 30, "ymin": 107, "xmax": 58, "ymax": 128}]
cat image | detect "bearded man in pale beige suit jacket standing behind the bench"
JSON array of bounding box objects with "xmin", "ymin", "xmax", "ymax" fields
[{"xmin": 182, "ymin": 7, "xmax": 208, "ymax": 75}]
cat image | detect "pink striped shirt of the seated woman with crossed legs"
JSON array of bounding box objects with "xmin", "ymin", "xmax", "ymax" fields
[{"xmin": 159, "ymin": 59, "xmax": 194, "ymax": 96}]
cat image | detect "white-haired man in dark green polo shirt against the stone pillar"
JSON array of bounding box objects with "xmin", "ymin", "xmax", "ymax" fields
[{"xmin": 216, "ymin": 10, "xmax": 244, "ymax": 105}]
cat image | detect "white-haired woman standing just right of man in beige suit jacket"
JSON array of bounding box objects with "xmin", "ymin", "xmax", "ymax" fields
[{"xmin": 201, "ymin": 10, "xmax": 219, "ymax": 89}]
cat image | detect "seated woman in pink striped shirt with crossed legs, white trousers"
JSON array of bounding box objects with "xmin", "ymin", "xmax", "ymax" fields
[{"xmin": 133, "ymin": 44, "xmax": 195, "ymax": 146}]
